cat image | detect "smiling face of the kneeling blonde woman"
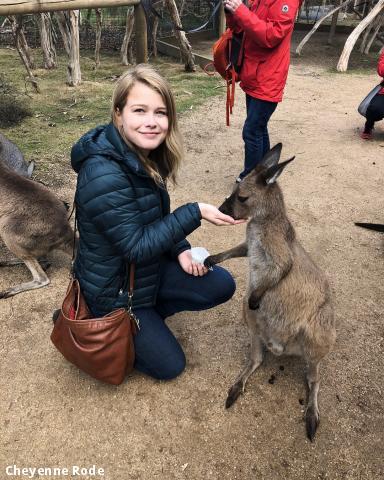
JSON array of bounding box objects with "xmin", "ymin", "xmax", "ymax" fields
[{"xmin": 117, "ymin": 82, "xmax": 168, "ymax": 156}]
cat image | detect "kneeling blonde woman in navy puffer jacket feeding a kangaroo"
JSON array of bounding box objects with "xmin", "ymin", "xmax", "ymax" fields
[{"xmin": 72, "ymin": 65, "xmax": 241, "ymax": 379}]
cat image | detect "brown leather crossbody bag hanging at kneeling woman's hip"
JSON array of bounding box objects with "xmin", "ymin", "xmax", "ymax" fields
[{"xmin": 51, "ymin": 216, "xmax": 139, "ymax": 385}]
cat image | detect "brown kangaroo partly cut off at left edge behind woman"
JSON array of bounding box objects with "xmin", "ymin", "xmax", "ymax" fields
[{"xmin": 0, "ymin": 162, "xmax": 74, "ymax": 298}]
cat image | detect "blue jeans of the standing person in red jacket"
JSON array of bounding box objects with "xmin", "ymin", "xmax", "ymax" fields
[{"xmin": 240, "ymin": 95, "xmax": 277, "ymax": 178}]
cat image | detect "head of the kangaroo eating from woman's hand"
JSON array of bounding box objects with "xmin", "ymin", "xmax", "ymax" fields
[{"xmin": 219, "ymin": 143, "xmax": 295, "ymax": 219}]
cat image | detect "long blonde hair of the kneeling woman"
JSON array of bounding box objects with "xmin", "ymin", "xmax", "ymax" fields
[{"xmin": 112, "ymin": 63, "xmax": 183, "ymax": 184}]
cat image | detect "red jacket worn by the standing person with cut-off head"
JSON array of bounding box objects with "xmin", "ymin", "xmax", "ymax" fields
[{"xmin": 227, "ymin": 0, "xmax": 300, "ymax": 102}]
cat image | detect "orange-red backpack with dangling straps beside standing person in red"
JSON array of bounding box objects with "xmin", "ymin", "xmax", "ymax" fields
[{"xmin": 212, "ymin": 28, "xmax": 244, "ymax": 126}]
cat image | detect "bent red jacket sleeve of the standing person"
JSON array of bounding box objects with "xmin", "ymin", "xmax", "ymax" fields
[{"xmin": 233, "ymin": 0, "xmax": 298, "ymax": 48}]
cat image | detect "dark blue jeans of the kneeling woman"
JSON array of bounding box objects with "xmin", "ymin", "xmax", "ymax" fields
[{"xmin": 134, "ymin": 261, "xmax": 236, "ymax": 380}]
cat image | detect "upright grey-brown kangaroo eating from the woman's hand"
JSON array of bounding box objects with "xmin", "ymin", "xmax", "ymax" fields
[{"xmin": 205, "ymin": 144, "xmax": 336, "ymax": 441}]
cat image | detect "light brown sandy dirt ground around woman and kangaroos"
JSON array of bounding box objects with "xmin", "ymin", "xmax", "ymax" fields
[{"xmin": 0, "ymin": 33, "xmax": 384, "ymax": 480}]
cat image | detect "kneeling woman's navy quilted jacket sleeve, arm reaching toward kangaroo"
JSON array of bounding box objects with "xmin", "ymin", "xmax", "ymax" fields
[{"xmin": 76, "ymin": 157, "xmax": 201, "ymax": 263}]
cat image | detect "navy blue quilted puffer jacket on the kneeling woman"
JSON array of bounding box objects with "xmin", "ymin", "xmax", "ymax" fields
[{"xmin": 72, "ymin": 124, "xmax": 201, "ymax": 315}]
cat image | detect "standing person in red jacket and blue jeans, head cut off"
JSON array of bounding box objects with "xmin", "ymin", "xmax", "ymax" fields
[{"xmin": 223, "ymin": 0, "xmax": 300, "ymax": 182}]
